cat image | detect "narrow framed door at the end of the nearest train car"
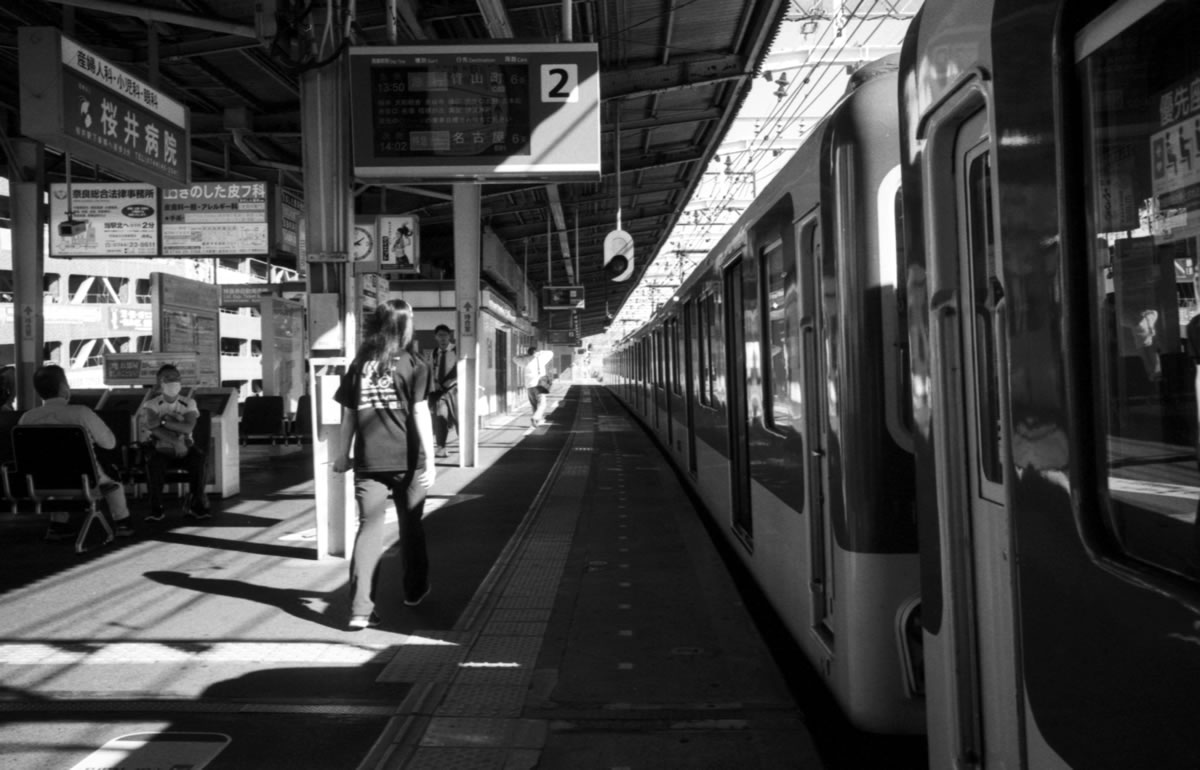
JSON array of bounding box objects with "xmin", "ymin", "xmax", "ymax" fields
[{"xmin": 931, "ymin": 102, "xmax": 1024, "ymax": 768}]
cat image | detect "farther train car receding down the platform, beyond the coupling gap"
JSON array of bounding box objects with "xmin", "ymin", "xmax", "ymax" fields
[{"xmin": 609, "ymin": 58, "xmax": 924, "ymax": 733}]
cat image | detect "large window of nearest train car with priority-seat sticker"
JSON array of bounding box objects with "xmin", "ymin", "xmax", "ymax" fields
[{"xmin": 1075, "ymin": 0, "xmax": 1200, "ymax": 578}]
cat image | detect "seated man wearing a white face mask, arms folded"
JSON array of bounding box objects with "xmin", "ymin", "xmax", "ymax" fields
[{"xmin": 138, "ymin": 363, "xmax": 212, "ymax": 522}]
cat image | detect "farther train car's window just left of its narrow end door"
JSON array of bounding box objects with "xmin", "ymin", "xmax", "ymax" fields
[{"xmin": 760, "ymin": 241, "xmax": 803, "ymax": 429}]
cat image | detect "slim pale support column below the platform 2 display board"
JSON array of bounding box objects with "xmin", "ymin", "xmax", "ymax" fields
[{"xmin": 454, "ymin": 182, "xmax": 482, "ymax": 468}]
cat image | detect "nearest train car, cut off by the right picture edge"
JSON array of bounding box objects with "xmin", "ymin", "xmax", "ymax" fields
[{"xmin": 901, "ymin": 0, "xmax": 1200, "ymax": 769}]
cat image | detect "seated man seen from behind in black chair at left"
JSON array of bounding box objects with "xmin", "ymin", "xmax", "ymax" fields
[{"xmin": 17, "ymin": 363, "xmax": 133, "ymax": 540}]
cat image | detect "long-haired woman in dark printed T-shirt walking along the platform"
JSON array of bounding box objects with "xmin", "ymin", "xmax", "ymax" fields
[{"xmin": 334, "ymin": 300, "xmax": 437, "ymax": 631}]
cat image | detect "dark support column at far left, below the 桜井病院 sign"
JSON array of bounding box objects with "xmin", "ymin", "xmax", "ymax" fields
[{"xmin": 10, "ymin": 139, "xmax": 46, "ymax": 409}]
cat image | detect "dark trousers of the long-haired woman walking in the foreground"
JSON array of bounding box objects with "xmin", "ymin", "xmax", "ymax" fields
[{"xmin": 350, "ymin": 470, "xmax": 430, "ymax": 615}]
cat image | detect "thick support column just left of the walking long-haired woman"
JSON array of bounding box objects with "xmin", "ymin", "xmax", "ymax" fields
[{"xmin": 300, "ymin": 55, "xmax": 358, "ymax": 558}]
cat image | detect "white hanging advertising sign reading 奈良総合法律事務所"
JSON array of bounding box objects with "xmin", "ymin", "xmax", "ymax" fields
[{"xmin": 49, "ymin": 182, "xmax": 158, "ymax": 257}]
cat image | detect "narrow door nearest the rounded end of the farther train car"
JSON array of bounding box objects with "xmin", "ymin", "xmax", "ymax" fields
[{"xmin": 797, "ymin": 211, "xmax": 834, "ymax": 645}]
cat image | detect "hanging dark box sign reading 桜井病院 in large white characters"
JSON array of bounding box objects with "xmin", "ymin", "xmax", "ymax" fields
[{"xmin": 17, "ymin": 26, "xmax": 191, "ymax": 187}]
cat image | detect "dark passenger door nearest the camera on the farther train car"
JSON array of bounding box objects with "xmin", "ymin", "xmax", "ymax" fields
[{"xmin": 725, "ymin": 255, "xmax": 754, "ymax": 542}]
